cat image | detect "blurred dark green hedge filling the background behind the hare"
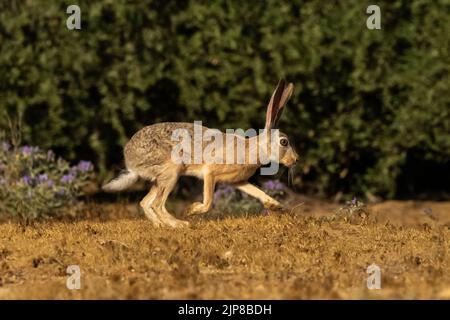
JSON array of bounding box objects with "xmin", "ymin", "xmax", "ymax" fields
[{"xmin": 0, "ymin": 0, "xmax": 450, "ymax": 199}]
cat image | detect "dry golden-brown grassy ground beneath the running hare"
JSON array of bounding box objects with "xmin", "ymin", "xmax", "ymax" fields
[{"xmin": 0, "ymin": 199, "xmax": 450, "ymax": 299}]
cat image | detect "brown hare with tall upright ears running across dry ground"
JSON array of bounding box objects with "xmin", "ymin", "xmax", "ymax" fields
[{"xmin": 103, "ymin": 80, "xmax": 299, "ymax": 228}]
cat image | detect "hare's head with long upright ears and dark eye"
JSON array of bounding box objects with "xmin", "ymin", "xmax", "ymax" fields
[{"xmin": 265, "ymin": 80, "xmax": 299, "ymax": 167}]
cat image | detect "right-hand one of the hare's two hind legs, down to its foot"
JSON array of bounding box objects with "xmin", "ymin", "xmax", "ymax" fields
[{"xmin": 152, "ymin": 170, "xmax": 189, "ymax": 228}]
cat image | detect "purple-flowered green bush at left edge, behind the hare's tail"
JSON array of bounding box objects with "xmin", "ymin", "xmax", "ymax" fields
[{"xmin": 0, "ymin": 142, "xmax": 93, "ymax": 219}]
